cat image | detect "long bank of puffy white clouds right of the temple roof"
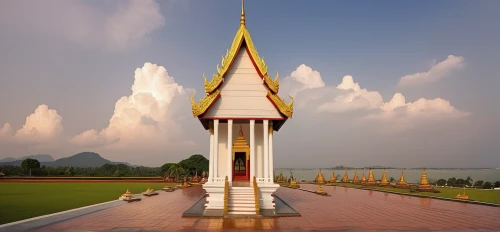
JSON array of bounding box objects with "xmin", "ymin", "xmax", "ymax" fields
[{"xmin": 284, "ymin": 64, "xmax": 469, "ymax": 131}]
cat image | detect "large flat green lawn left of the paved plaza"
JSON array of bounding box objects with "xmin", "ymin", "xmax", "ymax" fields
[{"xmin": 0, "ymin": 182, "xmax": 175, "ymax": 224}]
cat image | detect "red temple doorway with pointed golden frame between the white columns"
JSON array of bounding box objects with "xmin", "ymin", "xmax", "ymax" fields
[{"xmin": 233, "ymin": 128, "xmax": 250, "ymax": 181}]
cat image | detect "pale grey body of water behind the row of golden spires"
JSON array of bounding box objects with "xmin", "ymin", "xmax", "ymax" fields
[{"xmin": 274, "ymin": 168, "xmax": 500, "ymax": 183}]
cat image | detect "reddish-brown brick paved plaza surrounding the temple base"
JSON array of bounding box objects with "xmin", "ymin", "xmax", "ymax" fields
[{"xmin": 28, "ymin": 184, "xmax": 500, "ymax": 231}]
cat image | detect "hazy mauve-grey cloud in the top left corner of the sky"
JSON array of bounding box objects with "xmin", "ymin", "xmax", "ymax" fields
[{"xmin": 0, "ymin": 0, "xmax": 165, "ymax": 50}]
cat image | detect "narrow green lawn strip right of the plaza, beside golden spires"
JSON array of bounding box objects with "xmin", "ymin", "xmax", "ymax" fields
[{"xmin": 333, "ymin": 183, "xmax": 500, "ymax": 204}]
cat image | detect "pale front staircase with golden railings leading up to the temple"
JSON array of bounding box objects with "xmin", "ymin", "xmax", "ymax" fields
[{"xmin": 228, "ymin": 187, "xmax": 256, "ymax": 215}]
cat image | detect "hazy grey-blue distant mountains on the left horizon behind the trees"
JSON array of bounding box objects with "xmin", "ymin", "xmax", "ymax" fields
[{"xmin": 0, "ymin": 152, "xmax": 132, "ymax": 168}]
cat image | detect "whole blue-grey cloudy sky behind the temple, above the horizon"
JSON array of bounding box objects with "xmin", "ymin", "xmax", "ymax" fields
[{"xmin": 0, "ymin": 0, "xmax": 500, "ymax": 168}]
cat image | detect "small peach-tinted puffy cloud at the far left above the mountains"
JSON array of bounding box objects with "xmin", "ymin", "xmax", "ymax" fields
[{"xmin": 0, "ymin": 105, "xmax": 63, "ymax": 144}]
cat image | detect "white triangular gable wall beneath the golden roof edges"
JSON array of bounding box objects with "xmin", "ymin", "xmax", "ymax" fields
[{"xmin": 203, "ymin": 47, "xmax": 282, "ymax": 119}]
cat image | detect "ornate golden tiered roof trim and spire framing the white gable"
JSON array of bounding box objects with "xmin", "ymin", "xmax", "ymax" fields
[{"xmin": 191, "ymin": 0, "xmax": 294, "ymax": 130}]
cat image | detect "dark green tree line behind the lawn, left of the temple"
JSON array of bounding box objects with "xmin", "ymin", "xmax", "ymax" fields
[{"xmin": 0, "ymin": 154, "xmax": 209, "ymax": 178}]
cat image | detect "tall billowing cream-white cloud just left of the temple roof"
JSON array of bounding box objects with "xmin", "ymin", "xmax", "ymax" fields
[{"xmin": 71, "ymin": 63, "xmax": 192, "ymax": 149}]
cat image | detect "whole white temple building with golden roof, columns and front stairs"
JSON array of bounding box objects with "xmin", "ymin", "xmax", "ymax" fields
[{"xmin": 191, "ymin": 0, "xmax": 293, "ymax": 215}]
